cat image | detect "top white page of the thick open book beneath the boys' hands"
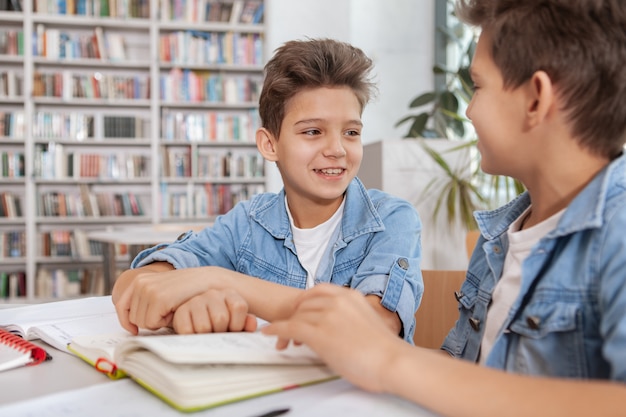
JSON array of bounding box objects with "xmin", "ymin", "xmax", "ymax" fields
[{"xmin": 116, "ymin": 332, "xmax": 321, "ymax": 364}]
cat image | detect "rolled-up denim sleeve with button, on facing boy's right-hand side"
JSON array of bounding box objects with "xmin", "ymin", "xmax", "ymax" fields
[{"xmin": 351, "ymin": 197, "xmax": 424, "ymax": 343}]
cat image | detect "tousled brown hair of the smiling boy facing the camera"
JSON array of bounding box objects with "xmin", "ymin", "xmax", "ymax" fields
[{"xmin": 259, "ymin": 39, "xmax": 376, "ymax": 138}]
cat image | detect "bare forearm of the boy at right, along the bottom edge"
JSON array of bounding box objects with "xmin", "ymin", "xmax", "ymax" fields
[{"xmin": 382, "ymin": 344, "xmax": 626, "ymax": 417}]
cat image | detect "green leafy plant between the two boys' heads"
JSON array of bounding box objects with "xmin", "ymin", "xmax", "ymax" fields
[{"xmin": 396, "ymin": 8, "xmax": 524, "ymax": 230}]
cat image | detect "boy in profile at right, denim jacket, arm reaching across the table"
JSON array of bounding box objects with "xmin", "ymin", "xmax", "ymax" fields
[{"xmin": 263, "ymin": 0, "xmax": 626, "ymax": 417}]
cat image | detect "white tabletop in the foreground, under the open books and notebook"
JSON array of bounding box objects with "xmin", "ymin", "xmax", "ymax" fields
[{"xmin": 0, "ymin": 342, "xmax": 437, "ymax": 417}]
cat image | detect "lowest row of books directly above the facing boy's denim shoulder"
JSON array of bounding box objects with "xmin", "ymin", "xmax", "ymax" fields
[{"xmin": 160, "ymin": 183, "xmax": 265, "ymax": 220}]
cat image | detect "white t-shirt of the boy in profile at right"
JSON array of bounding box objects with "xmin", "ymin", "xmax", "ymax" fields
[{"xmin": 479, "ymin": 207, "xmax": 565, "ymax": 364}]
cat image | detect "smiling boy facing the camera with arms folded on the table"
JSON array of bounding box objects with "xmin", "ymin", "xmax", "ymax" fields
[{"xmin": 113, "ymin": 39, "xmax": 423, "ymax": 341}]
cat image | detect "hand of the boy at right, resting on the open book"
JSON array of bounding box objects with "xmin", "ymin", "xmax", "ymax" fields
[{"xmin": 262, "ymin": 284, "xmax": 398, "ymax": 391}]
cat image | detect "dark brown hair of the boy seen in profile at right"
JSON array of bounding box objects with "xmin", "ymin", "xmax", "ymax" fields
[{"xmin": 456, "ymin": 0, "xmax": 626, "ymax": 158}]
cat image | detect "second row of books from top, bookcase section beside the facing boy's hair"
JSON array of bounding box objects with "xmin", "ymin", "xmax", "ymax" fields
[{"xmin": 159, "ymin": 30, "xmax": 263, "ymax": 65}]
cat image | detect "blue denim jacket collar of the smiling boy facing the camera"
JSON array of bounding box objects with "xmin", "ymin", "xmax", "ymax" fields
[{"xmin": 250, "ymin": 178, "xmax": 385, "ymax": 244}]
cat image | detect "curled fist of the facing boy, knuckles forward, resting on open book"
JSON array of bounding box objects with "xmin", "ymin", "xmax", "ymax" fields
[{"xmin": 171, "ymin": 289, "xmax": 257, "ymax": 334}]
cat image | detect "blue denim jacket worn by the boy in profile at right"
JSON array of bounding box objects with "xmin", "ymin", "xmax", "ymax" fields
[{"xmin": 442, "ymin": 155, "xmax": 626, "ymax": 382}]
